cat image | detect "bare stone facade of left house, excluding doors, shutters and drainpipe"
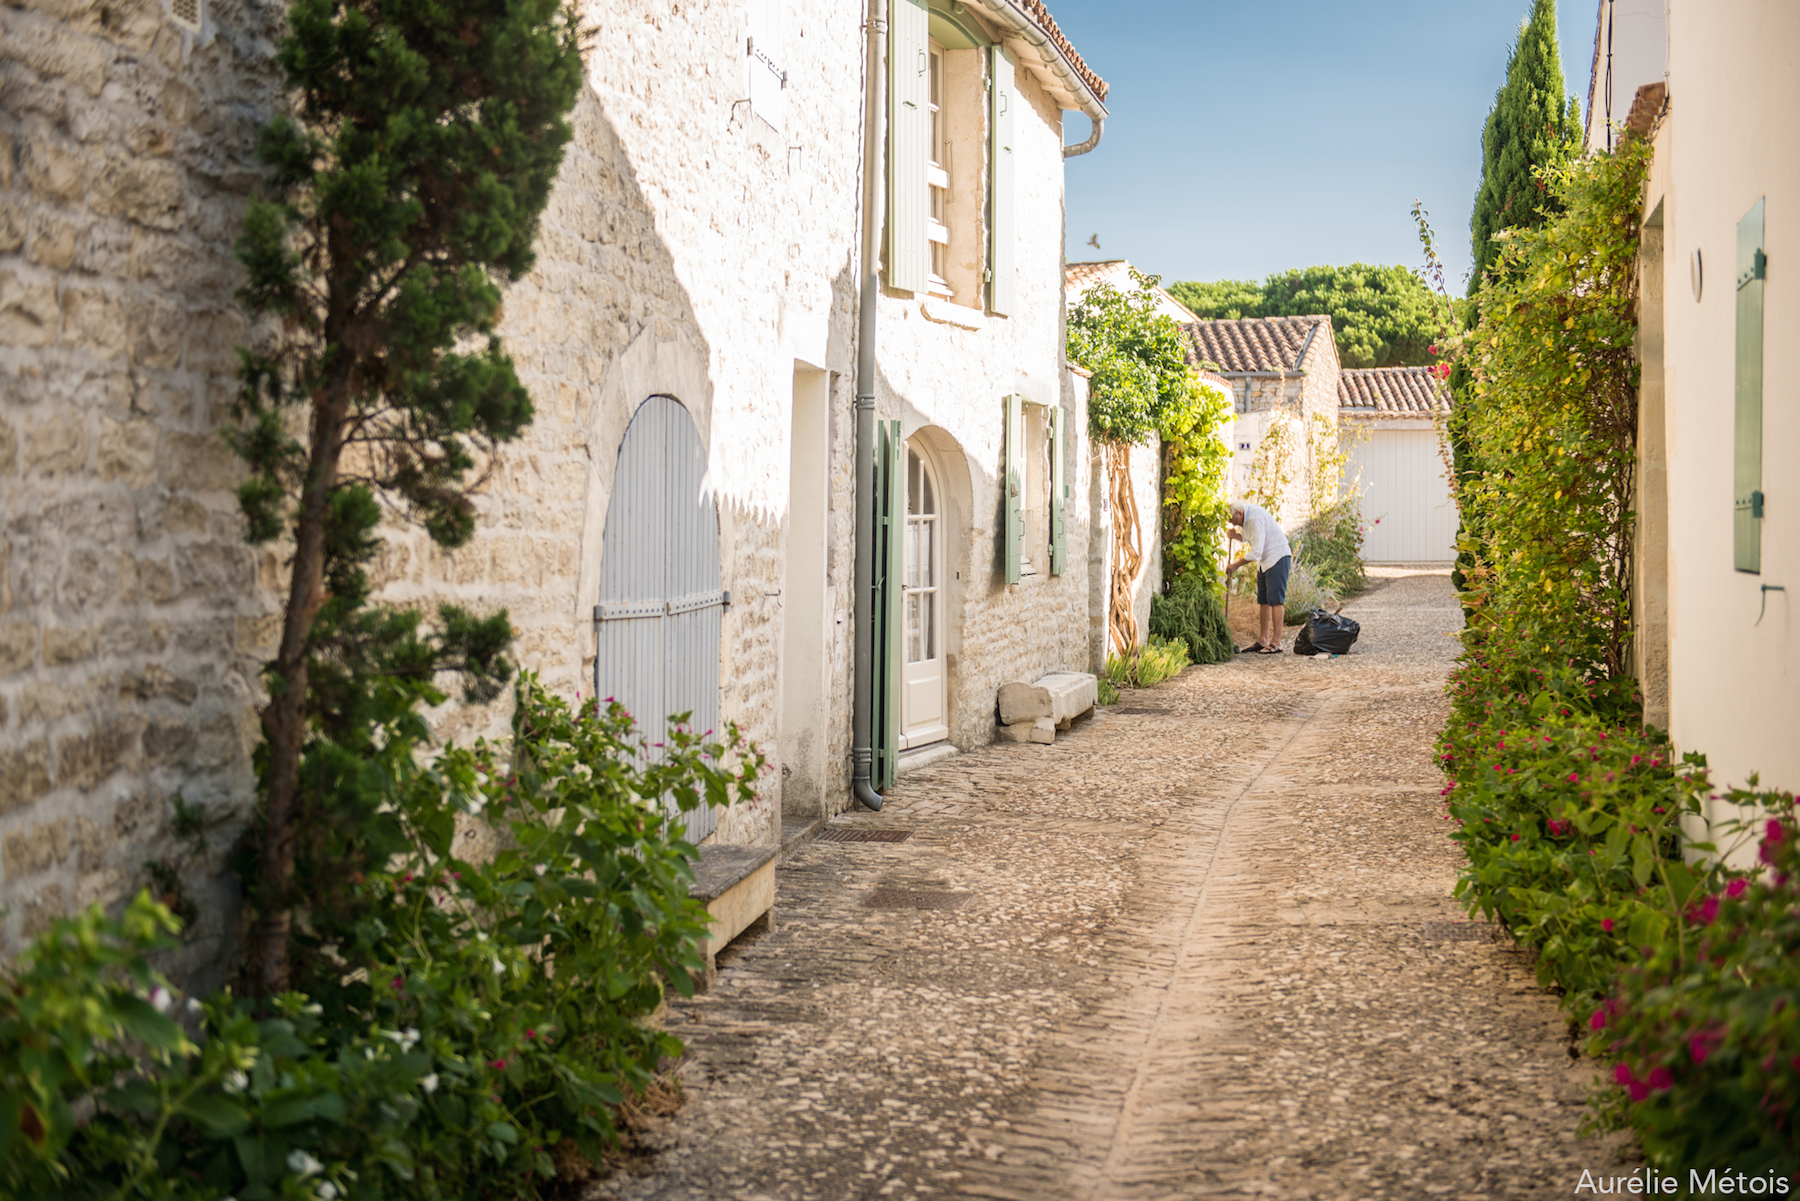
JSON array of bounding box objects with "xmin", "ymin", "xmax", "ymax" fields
[{"xmin": 0, "ymin": 0, "xmax": 1093, "ymax": 949}]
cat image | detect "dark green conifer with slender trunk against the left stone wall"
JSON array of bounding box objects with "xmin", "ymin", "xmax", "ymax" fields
[{"xmin": 227, "ymin": 0, "xmax": 581, "ymax": 992}]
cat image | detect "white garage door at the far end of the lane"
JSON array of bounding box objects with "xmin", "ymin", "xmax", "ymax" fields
[{"xmin": 1348, "ymin": 429, "xmax": 1456, "ymax": 564}]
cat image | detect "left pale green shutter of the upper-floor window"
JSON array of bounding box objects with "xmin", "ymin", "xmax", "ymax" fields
[{"xmin": 886, "ymin": 0, "xmax": 931, "ymax": 292}]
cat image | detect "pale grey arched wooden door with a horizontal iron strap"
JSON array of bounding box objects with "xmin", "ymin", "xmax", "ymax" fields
[{"xmin": 594, "ymin": 396, "xmax": 725, "ymax": 841}]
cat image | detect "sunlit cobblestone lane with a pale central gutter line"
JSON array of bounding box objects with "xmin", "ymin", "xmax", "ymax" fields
[{"xmin": 608, "ymin": 569, "xmax": 1618, "ymax": 1201}]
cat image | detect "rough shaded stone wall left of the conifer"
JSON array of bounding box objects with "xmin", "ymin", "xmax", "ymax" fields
[{"xmin": 0, "ymin": 0, "xmax": 277, "ymax": 949}]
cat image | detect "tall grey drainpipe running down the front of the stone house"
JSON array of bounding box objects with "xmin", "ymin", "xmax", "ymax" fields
[{"xmin": 850, "ymin": 0, "xmax": 887, "ymax": 808}]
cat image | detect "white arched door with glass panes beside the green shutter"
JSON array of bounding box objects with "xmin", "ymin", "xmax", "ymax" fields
[{"xmin": 900, "ymin": 447, "xmax": 950, "ymax": 751}]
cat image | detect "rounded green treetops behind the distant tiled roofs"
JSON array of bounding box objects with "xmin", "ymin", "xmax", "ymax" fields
[{"xmin": 1168, "ymin": 263, "xmax": 1435, "ymax": 367}]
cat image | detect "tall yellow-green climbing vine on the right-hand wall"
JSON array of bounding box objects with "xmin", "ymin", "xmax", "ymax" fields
[{"xmin": 1456, "ymin": 139, "xmax": 1649, "ymax": 679}]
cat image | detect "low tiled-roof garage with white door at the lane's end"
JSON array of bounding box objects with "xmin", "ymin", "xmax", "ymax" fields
[{"xmin": 1337, "ymin": 367, "xmax": 1456, "ymax": 564}]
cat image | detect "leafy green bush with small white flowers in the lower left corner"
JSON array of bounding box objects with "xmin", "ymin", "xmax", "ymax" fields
[{"xmin": 0, "ymin": 677, "xmax": 761, "ymax": 1201}]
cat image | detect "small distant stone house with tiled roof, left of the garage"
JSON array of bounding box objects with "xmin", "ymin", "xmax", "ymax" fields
[{"xmin": 1186, "ymin": 315, "xmax": 1341, "ymax": 528}]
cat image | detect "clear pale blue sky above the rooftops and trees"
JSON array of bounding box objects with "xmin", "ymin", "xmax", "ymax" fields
[{"xmin": 1049, "ymin": 0, "xmax": 1597, "ymax": 292}]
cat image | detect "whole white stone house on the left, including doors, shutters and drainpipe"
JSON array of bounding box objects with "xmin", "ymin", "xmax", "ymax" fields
[{"xmin": 0, "ymin": 0, "xmax": 1105, "ymax": 947}]
